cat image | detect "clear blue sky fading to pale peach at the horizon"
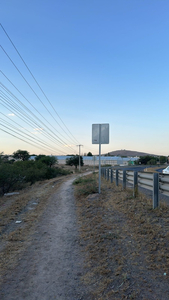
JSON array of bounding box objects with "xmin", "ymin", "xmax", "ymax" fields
[{"xmin": 0, "ymin": 0, "xmax": 169, "ymax": 155}]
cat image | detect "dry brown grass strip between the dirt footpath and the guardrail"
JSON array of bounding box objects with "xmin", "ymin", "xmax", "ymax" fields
[{"xmin": 76, "ymin": 173, "xmax": 169, "ymax": 300}]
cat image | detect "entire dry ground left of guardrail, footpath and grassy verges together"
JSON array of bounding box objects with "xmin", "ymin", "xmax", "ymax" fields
[{"xmin": 0, "ymin": 174, "xmax": 169, "ymax": 300}]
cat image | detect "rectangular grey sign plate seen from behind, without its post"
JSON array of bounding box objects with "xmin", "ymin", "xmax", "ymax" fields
[{"xmin": 92, "ymin": 124, "xmax": 109, "ymax": 144}]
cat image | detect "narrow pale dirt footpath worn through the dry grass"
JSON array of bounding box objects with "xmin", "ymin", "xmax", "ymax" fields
[{"xmin": 0, "ymin": 178, "xmax": 90, "ymax": 300}]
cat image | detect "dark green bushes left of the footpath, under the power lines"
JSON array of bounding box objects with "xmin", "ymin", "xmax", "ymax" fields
[{"xmin": 0, "ymin": 150, "xmax": 71, "ymax": 195}]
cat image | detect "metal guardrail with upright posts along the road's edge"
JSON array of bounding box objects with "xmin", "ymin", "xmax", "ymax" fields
[{"xmin": 101, "ymin": 167, "xmax": 169, "ymax": 208}]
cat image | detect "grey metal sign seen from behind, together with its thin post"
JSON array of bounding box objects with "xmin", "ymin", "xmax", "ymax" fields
[{"xmin": 92, "ymin": 124, "xmax": 109, "ymax": 194}]
